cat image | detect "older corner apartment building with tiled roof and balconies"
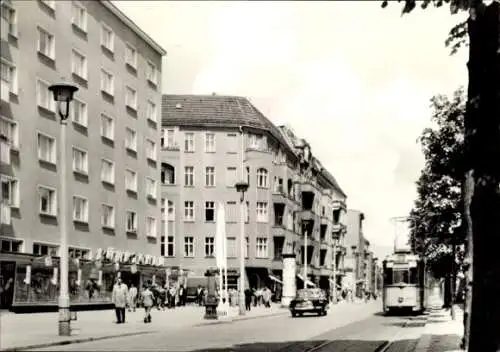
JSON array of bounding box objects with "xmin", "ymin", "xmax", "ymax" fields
[{"xmin": 161, "ymin": 95, "xmax": 346, "ymax": 296}]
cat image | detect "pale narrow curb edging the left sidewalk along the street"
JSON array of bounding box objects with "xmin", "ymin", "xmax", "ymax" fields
[{"xmin": 0, "ymin": 312, "xmax": 286, "ymax": 352}]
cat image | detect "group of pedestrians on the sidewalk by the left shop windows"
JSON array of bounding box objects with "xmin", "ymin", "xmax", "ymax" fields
[{"xmin": 111, "ymin": 278, "xmax": 204, "ymax": 324}]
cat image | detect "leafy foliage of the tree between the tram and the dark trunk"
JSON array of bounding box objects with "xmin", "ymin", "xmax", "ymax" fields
[{"xmin": 410, "ymin": 88, "xmax": 466, "ymax": 275}]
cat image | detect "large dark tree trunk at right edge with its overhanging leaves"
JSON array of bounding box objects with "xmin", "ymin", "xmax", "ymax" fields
[{"xmin": 382, "ymin": 0, "xmax": 500, "ymax": 352}]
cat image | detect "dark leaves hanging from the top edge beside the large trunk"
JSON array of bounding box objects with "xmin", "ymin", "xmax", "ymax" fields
[{"xmin": 382, "ymin": 0, "xmax": 483, "ymax": 55}]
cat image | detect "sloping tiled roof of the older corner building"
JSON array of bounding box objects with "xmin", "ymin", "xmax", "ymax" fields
[{"xmin": 161, "ymin": 94, "xmax": 288, "ymax": 146}]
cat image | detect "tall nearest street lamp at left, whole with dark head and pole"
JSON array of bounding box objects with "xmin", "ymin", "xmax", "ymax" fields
[{"xmin": 49, "ymin": 83, "xmax": 78, "ymax": 336}]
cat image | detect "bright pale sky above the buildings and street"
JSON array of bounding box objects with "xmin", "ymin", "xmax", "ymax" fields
[{"xmin": 113, "ymin": 1, "xmax": 467, "ymax": 257}]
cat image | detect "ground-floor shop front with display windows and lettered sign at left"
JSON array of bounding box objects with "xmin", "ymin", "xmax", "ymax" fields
[{"xmin": 0, "ymin": 250, "xmax": 172, "ymax": 312}]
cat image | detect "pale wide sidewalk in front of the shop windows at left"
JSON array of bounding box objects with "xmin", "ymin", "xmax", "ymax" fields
[{"xmin": 0, "ymin": 304, "xmax": 288, "ymax": 350}]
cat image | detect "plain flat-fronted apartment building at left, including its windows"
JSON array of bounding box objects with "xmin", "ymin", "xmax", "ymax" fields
[{"xmin": 0, "ymin": 0, "xmax": 166, "ymax": 308}]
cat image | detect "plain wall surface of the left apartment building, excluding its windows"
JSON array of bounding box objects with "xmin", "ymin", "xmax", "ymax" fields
[{"xmin": 0, "ymin": 1, "xmax": 162, "ymax": 255}]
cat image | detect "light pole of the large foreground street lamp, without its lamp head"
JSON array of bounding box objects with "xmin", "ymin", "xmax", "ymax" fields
[{"xmin": 59, "ymin": 118, "xmax": 71, "ymax": 336}]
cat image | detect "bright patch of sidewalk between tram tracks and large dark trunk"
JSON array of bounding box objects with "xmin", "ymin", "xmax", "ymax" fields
[{"xmin": 414, "ymin": 305, "xmax": 464, "ymax": 352}]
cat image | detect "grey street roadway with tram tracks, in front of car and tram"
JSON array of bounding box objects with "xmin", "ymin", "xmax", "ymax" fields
[{"xmin": 33, "ymin": 301, "xmax": 422, "ymax": 352}]
